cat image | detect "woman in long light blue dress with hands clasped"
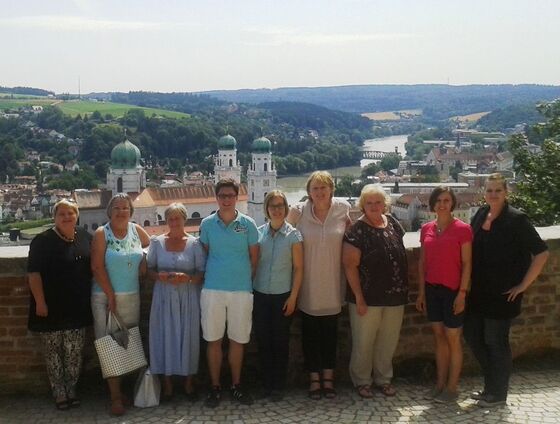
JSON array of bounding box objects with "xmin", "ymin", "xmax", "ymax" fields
[{"xmin": 148, "ymin": 203, "xmax": 206, "ymax": 401}]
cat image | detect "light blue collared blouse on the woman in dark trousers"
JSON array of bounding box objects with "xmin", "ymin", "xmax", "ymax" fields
[{"xmin": 253, "ymin": 222, "xmax": 303, "ymax": 294}]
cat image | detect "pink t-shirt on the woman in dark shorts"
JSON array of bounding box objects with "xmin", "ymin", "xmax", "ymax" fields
[{"xmin": 420, "ymin": 218, "xmax": 473, "ymax": 290}]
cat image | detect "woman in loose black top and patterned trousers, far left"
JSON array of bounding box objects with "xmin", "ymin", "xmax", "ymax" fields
[{"xmin": 27, "ymin": 200, "xmax": 92, "ymax": 410}]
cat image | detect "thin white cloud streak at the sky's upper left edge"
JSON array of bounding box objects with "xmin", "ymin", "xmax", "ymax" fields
[{"xmin": 0, "ymin": 15, "xmax": 171, "ymax": 31}]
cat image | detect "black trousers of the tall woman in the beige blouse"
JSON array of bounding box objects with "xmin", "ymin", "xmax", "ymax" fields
[{"xmin": 301, "ymin": 312, "xmax": 339, "ymax": 372}]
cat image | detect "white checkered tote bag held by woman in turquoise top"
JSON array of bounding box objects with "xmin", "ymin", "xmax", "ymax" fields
[{"xmin": 95, "ymin": 312, "xmax": 148, "ymax": 378}]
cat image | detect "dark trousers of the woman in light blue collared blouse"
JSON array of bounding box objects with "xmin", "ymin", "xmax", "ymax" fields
[{"xmin": 253, "ymin": 291, "xmax": 292, "ymax": 390}]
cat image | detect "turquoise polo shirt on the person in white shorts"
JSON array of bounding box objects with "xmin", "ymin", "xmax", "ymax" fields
[{"xmin": 200, "ymin": 211, "xmax": 259, "ymax": 292}]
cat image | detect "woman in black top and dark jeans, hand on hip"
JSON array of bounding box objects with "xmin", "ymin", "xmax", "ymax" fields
[{"xmin": 464, "ymin": 174, "xmax": 548, "ymax": 407}]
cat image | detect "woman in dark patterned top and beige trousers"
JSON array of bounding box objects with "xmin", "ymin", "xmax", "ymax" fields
[{"xmin": 342, "ymin": 184, "xmax": 408, "ymax": 399}]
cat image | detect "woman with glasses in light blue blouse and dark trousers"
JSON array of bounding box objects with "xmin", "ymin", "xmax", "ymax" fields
[{"xmin": 253, "ymin": 190, "xmax": 303, "ymax": 399}]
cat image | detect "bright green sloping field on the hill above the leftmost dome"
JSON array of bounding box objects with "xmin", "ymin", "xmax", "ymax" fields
[{"xmin": 57, "ymin": 100, "xmax": 189, "ymax": 118}]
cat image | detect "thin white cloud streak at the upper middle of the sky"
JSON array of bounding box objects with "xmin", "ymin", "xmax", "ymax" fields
[{"xmin": 245, "ymin": 29, "xmax": 417, "ymax": 46}]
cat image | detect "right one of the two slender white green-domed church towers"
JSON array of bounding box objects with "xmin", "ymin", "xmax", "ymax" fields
[{"xmin": 247, "ymin": 137, "xmax": 276, "ymax": 225}]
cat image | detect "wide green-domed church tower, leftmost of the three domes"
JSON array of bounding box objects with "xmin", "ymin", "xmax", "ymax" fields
[{"xmin": 107, "ymin": 140, "xmax": 146, "ymax": 196}]
